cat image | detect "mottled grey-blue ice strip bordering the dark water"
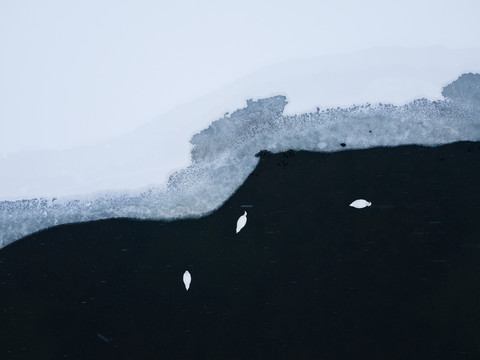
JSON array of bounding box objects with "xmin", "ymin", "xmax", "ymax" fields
[{"xmin": 0, "ymin": 73, "xmax": 480, "ymax": 247}]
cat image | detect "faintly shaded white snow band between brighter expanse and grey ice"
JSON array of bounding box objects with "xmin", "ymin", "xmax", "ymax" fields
[{"xmin": 0, "ymin": 47, "xmax": 480, "ymax": 200}]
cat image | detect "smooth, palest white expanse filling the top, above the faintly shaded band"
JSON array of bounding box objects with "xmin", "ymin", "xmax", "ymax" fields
[{"xmin": 0, "ymin": 0, "xmax": 480, "ymax": 154}]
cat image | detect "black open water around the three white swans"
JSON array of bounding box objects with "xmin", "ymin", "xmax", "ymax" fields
[{"xmin": 0, "ymin": 142, "xmax": 480, "ymax": 359}]
